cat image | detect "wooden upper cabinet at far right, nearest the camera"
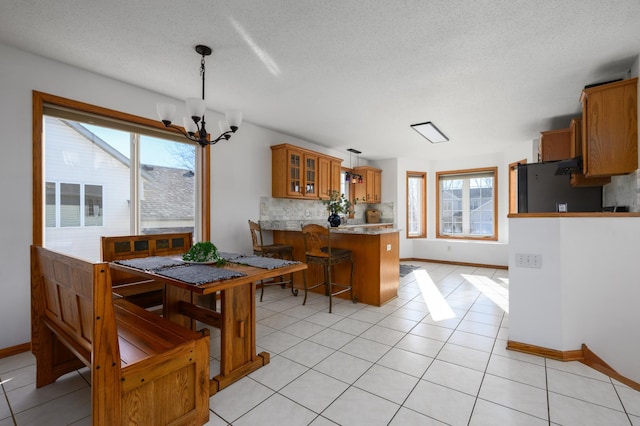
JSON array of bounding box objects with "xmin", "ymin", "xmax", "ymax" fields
[{"xmin": 580, "ymin": 78, "xmax": 638, "ymax": 177}]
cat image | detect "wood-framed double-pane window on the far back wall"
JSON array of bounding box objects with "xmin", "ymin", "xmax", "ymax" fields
[{"xmin": 436, "ymin": 167, "xmax": 498, "ymax": 240}]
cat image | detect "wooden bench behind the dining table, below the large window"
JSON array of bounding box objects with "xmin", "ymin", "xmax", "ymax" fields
[{"xmin": 100, "ymin": 232, "xmax": 193, "ymax": 308}]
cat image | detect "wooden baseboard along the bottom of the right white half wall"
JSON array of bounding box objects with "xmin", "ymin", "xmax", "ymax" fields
[{"xmin": 507, "ymin": 340, "xmax": 640, "ymax": 392}]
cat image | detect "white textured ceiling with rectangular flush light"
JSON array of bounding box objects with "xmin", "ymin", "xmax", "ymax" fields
[{"xmin": 0, "ymin": 0, "xmax": 640, "ymax": 160}]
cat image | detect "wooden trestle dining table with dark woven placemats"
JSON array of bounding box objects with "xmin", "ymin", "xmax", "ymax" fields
[{"xmin": 109, "ymin": 256, "xmax": 307, "ymax": 395}]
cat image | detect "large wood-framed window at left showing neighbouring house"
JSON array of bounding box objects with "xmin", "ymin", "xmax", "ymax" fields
[{"xmin": 33, "ymin": 92, "xmax": 209, "ymax": 261}]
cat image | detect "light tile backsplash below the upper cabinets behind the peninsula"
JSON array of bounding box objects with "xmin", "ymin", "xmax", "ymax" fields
[{"xmin": 260, "ymin": 197, "xmax": 394, "ymax": 223}]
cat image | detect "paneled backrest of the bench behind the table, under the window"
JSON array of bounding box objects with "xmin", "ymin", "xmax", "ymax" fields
[{"xmin": 100, "ymin": 232, "xmax": 193, "ymax": 262}]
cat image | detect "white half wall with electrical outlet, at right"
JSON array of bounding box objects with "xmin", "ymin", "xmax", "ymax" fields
[{"xmin": 509, "ymin": 217, "xmax": 640, "ymax": 382}]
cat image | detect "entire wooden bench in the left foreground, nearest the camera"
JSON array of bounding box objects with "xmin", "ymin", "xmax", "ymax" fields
[{"xmin": 31, "ymin": 246, "xmax": 209, "ymax": 425}]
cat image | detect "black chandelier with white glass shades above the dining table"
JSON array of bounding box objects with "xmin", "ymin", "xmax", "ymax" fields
[{"xmin": 156, "ymin": 44, "xmax": 242, "ymax": 148}]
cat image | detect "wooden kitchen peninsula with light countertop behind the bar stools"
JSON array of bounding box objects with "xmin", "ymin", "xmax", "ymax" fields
[{"xmin": 262, "ymin": 221, "xmax": 400, "ymax": 306}]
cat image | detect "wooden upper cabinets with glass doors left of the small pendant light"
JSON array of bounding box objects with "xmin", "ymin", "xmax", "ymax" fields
[{"xmin": 271, "ymin": 144, "xmax": 342, "ymax": 200}]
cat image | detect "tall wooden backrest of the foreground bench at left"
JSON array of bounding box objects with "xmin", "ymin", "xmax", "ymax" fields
[{"xmin": 31, "ymin": 246, "xmax": 121, "ymax": 424}]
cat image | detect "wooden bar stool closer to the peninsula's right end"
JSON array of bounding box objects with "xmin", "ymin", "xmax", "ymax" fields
[{"xmin": 302, "ymin": 224, "xmax": 358, "ymax": 313}]
